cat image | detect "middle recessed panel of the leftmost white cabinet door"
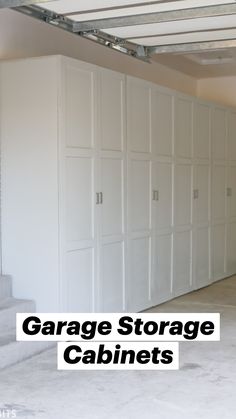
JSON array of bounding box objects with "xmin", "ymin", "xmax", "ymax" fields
[{"xmin": 66, "ymin": 157, "xmax": 94, "ymax": 242}]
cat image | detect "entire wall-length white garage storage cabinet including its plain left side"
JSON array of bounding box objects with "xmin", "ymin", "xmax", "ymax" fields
[{"xmin": 0, "ymin": 56, "xmax": 236, "ymax": 312}]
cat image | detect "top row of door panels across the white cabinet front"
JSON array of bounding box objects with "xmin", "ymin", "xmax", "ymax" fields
[{"xmin": 65, "ymin": 66, "xmax": 236, "ymax": 161}]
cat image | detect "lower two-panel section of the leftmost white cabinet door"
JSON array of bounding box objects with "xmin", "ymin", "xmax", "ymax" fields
[{"xmin": 64, "ymin": 157, "xmax": 96, "ymax": 312}]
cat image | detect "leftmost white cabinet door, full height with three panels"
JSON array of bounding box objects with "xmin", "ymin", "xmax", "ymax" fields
[{"xmin": 62, "ymin": 59, "xmax": 98, "ymax": 312}]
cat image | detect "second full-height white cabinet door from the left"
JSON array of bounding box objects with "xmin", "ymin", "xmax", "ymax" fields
[{"xmin": 97, "ymin": 69, "xmax": 126, "ymax": 312}]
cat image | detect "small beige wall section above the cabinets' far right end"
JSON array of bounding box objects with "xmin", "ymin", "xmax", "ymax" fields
[{"xmin": 197, "ymin": 76, "xmax": 236, "ymax": 106}]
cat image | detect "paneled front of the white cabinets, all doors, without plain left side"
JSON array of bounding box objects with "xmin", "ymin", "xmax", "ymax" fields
[{"xmin": 65, "ymin": 62, "xmax": 236, "ymax": 311}]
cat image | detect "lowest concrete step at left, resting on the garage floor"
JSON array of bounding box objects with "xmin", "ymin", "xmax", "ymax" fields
[{"xmin": 0, "ymin": 328, "xmax": 54, "ymax": 369}]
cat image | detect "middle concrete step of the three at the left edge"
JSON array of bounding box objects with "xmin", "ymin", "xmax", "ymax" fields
[{"xmin": 0, "ymin": 297, "xmax": 35, "ymax": 333}]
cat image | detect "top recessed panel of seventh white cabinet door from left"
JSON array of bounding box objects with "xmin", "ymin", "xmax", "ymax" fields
[{"xmin": 211, "ymin": 108, "xmax": 226, "ymax": 160}]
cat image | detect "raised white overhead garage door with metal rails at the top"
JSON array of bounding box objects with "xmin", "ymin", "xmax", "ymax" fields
[{"xmin": 3, "ymin": 0, "xmax": 236, "ymax": 65}]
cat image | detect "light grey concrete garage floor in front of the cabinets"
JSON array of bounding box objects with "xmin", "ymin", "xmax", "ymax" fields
[{"xmin": 0, "ymin": 277, "xmax": 236, "ymax": 419}]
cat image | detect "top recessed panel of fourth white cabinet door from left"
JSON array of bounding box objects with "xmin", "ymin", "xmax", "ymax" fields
[{"xmin": 152, "ymin": 90, "xmax": 173, "ymax": 156}]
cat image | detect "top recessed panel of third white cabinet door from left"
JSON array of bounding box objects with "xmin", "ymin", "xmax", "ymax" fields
[{"xmin": 127, "ymin": 79, "xmax": 151, "ymax": 152}]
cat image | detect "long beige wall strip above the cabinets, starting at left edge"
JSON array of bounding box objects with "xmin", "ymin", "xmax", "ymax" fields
[{"xmin": 0, "ymin": 9, "xmax": 197, "ymax": 95}]
